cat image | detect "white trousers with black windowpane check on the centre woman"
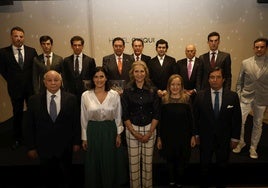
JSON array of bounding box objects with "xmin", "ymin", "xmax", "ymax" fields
[{"xmin": 126, "ymin": 124, "xmax": 156, "ymax": 188}]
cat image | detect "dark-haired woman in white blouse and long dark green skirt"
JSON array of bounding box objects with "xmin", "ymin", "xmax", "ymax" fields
[{"xmin": 81, "ymin": 66, "xmax": 124, "ymax": 188}]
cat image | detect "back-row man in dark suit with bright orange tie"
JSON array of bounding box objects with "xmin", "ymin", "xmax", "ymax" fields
[{"xmin": 102, "ymin": 37, "xmax": 134, "ymax": 84}]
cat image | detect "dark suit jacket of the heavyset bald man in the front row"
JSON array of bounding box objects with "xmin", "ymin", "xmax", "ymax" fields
[{"xmin": 25, "ymin": 91, "xmax": 81, "ymax": 158}]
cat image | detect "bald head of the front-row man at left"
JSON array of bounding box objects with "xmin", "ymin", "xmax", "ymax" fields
[{"xmin": 44, "ymin": 70, "xmax": 62, "ymax": 94}]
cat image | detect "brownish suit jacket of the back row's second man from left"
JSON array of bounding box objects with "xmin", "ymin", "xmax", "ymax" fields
[{"xmin": 33, "ymin": 53, "xmax": 63, "ymax": 94}]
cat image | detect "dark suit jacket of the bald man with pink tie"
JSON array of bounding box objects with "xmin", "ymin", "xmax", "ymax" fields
[{"xmin": 176, "ymin": 57, "xmax": 200, "ymax": 90}]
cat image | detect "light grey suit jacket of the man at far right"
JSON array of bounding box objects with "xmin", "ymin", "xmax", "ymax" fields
[{"xmin": 236, "ymin": 56, "xmax": 268, "ymax": 106}]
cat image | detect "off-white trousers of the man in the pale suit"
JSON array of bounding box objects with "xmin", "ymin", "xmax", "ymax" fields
[{"xmin": 240, "ymin": 101, "xmax": 266, "ymax": 150}]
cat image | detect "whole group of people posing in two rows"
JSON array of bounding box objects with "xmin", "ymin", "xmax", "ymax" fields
[{"xmin": 0, "ymin": 27, "xmax": 268, "ymax": 188}]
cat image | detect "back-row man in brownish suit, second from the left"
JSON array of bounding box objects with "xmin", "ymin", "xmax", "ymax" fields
[{"xmin": 33, "ymin": 35, "xmax": 63, "ymax": 94}]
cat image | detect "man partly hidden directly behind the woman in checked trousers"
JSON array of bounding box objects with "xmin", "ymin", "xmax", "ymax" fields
[{"xmin": 132, "ymin": 38, "xmax": 151, "ymax": 64}]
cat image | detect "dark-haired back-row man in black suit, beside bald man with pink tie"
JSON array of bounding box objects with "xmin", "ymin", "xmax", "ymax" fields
[{"xmin": 147, "ymin": 39, "xmax": 176, "ymax": 97}]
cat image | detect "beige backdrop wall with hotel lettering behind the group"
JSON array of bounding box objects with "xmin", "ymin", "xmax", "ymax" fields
[{"xmin": 0, "ymin": 0, "xmax": 268, "ymax": 122}]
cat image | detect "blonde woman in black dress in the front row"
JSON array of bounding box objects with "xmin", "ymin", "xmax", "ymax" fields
[{"xmin": 157, "ymin": 74, "xmax": 196, "ymax": 187}]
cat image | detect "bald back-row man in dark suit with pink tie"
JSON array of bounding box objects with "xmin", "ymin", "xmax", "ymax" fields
[{"xmin": 176, "ymin": 44, "xmax": 200, "ymax": 102}]
